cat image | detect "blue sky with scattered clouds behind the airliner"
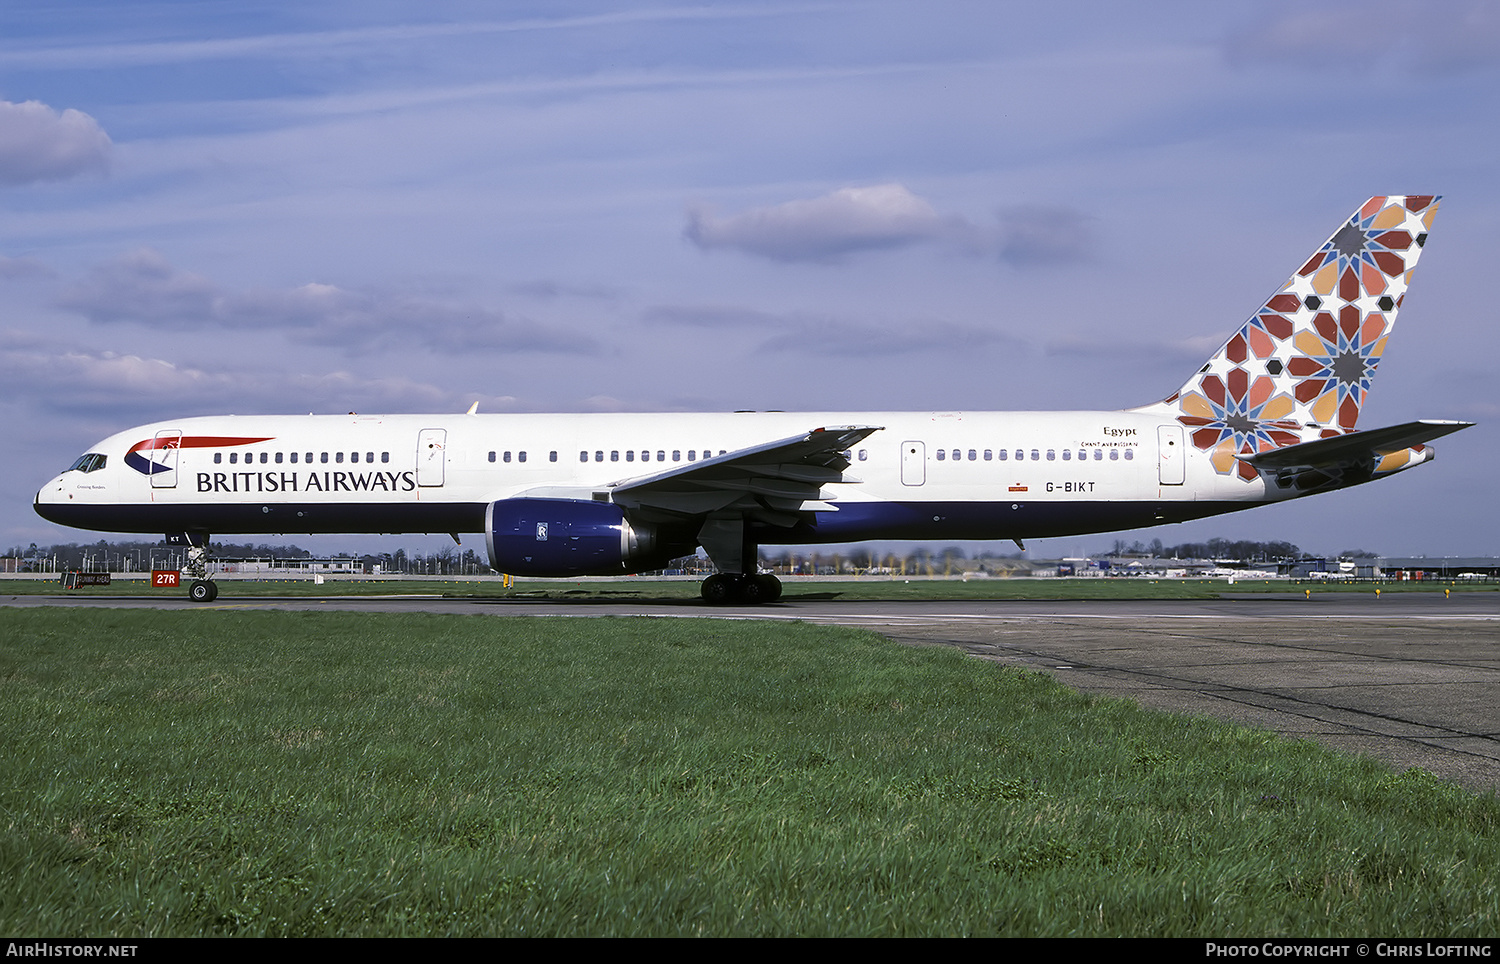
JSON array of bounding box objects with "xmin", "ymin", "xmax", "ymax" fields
[{"xmin": 0, "ymin": 0, "xmax": 1500, "ymax": 555}]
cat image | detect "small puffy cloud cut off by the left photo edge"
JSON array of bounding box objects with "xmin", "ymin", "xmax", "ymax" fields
[{"xmin": 0, "ymin": 100, "xmax": 110, "ymax": 184}]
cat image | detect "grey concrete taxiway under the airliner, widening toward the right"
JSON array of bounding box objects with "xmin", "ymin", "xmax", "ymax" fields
[{"xmin": 11, "ymin": 589, "xmax": 1500, "ymax": 792}]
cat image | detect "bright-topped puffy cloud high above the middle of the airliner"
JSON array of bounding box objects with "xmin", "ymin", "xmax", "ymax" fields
[{"xmin": 684, "ymin": 184, "xmax": 974, "ymax": 262}]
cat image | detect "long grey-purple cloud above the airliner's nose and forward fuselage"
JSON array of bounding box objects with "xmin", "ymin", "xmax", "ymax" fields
[{"xmin": 57, "ymin": 247, "xmax": 599, "ymax": 354}]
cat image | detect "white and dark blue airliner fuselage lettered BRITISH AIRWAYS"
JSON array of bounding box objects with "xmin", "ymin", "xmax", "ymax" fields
[{"xmin": 36, "ymin": 412, "xmax": 1296, "ymax": 543}]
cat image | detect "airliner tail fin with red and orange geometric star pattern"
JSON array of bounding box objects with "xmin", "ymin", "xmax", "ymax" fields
[{"xmin": 1149, "ymin": 195, "xmax": 1439, "ymax": 481}]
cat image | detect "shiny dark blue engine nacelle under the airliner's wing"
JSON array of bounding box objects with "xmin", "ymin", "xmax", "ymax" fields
[{"xmin": 485, "ymin": 499, "xmax": 663, "ymax": 576}]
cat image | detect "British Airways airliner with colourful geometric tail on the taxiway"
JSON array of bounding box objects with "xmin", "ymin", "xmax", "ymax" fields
[{"xmin": 36, "ymin": 196, "xmax": 1473, "ymax": 603}]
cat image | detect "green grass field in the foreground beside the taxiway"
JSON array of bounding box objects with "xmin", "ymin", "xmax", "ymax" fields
[{"xmin": 0, "ymin": 609, "xmax": 1500, "ymax": 937}]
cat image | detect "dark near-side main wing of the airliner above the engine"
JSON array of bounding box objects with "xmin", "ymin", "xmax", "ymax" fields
[{"xmin": 611, "ymin": 426, "xmax": 881, "ymax": 526}]
